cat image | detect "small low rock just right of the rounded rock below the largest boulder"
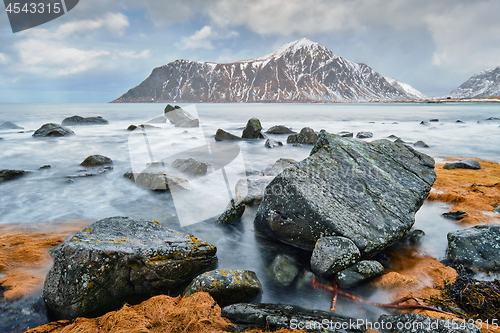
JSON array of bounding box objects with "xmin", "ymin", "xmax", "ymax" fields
[{"xmin": 335, "ymin": 260, "xmax": 384, "ymax": 288}]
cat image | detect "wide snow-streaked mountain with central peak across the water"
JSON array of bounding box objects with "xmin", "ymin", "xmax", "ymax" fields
[{"xmin": 114, "ymin": 38, "xmax": 424, "ymax": 103}]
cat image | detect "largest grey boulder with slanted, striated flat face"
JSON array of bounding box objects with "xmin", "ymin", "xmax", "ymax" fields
[{"xmin": 255, "ymin": 131, "xmax": 436, "ymax": 257}]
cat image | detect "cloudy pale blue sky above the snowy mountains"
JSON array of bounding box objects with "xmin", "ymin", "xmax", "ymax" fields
[{"xmin": 0, "ymin": 0, "xmax": 500, "ymax": 103}]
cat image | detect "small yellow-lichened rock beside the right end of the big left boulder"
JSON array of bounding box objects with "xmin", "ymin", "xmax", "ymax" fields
[{"xmin": 184, "ymin": 269, "xmax": 262, "ymax": 307}]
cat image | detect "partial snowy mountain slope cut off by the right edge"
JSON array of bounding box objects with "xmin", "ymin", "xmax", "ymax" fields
[{"xmin": 450, "ymin": 66, "xmax": 500, "ymax": 98}]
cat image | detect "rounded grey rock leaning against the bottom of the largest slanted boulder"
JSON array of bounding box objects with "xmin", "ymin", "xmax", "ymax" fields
[{"xmin": 311, "ymin": 236, "xmax": 361, "ymax": 278}]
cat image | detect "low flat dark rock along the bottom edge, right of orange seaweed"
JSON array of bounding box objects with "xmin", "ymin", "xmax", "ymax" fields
[{"xmin": 222, "ymin": 303, "xmax": 365, "ymax": 333}]
